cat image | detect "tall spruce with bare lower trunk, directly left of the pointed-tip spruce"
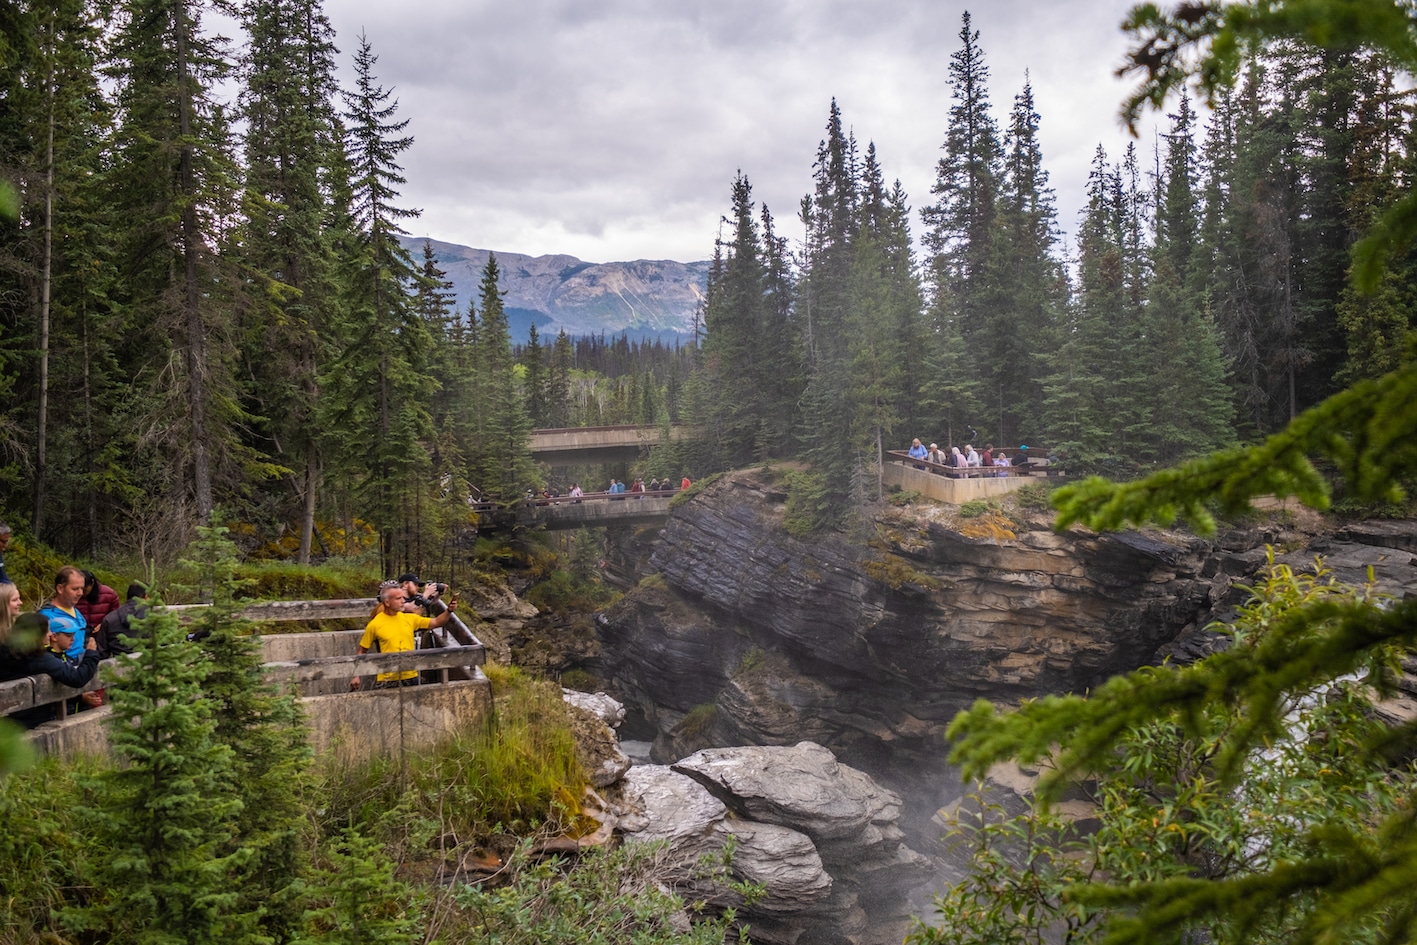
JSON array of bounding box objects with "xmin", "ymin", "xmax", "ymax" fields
[{"xmin": 231, "ymin": 0, "xmax": 341, "ymax": 564}]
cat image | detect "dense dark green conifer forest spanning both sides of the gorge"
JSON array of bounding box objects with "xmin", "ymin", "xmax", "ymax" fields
[{"xmin": 0, "ymin": 0, "xmax": 1417, "ymax": 564}]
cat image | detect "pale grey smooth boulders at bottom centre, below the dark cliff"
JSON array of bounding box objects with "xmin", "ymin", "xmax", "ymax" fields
[{"xmin": 618, "ymin": 742, "xmax": 930, "ymax": 945}]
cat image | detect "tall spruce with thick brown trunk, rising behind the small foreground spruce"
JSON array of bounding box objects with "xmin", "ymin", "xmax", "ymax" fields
[{"xmin": 106, "ymin": 0, "xmax": 245, "ymax": 523}]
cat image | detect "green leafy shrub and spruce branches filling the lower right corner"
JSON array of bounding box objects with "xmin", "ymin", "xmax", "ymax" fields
[{"xmin": 910, "ymin": 561, "xmax": 1417, "ymax": 945}]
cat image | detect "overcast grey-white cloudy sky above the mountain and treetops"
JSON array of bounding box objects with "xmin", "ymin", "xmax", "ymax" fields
[{"xmin": 315, "ymin": 0, "xmax": 1152, "ymax": 262}]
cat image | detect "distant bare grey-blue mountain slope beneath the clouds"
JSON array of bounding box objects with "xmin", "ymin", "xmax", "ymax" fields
[{"xmin": 401, "ymin": 237, "xmax": 709, "ymax": 341}]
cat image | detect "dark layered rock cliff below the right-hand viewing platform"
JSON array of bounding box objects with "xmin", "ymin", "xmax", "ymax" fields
[{"xmin": 599, "ymin": 472, "xmax": 1254, "ymax": 781}]
